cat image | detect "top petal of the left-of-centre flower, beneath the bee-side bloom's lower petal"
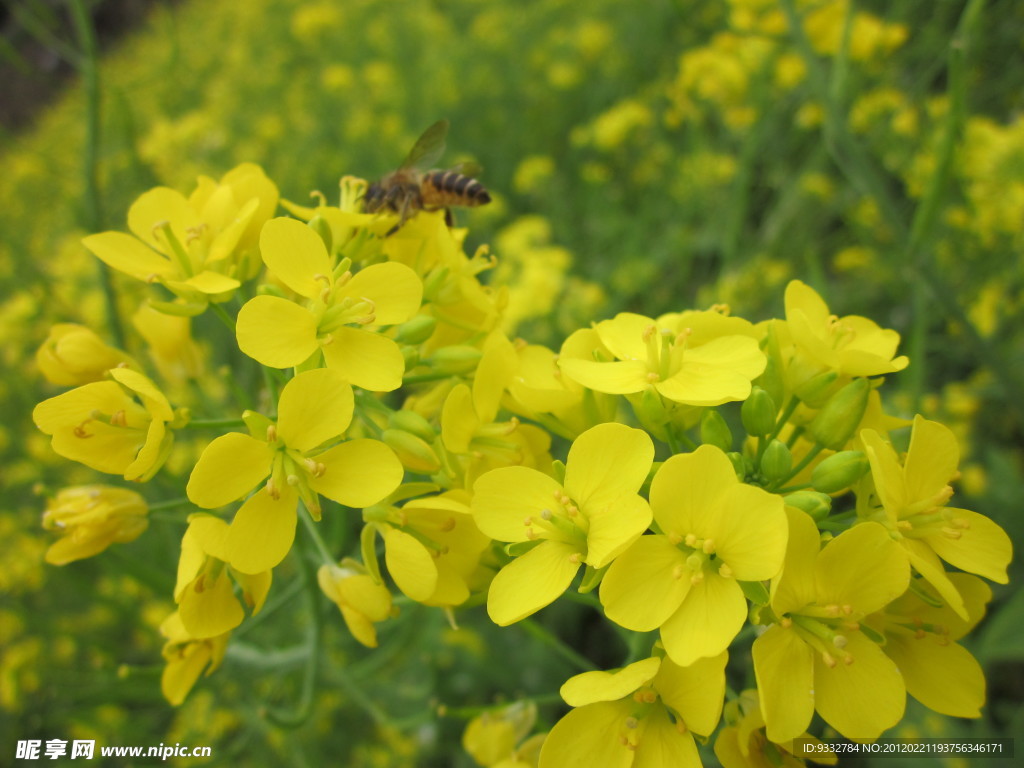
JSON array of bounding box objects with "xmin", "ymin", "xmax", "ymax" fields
[{"xmin": 278, "ymin": 368, "xmax": 354, "ymax": 452}]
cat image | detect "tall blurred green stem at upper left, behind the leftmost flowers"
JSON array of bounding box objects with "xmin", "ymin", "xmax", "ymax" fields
[{"xmin": 68, "ymin": 0, "xmax": 125, "ymax": 348}]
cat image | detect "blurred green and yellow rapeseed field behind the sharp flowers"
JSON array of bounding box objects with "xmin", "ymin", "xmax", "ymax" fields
[{"xmin": 0, "ymin": 0, "xmax": 1024, "ymax": 766}]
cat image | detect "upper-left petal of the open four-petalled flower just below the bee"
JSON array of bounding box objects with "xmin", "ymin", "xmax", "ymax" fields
[{"xmin": 259, "ymin": 216, "xmax": 333, "ymax": 301}]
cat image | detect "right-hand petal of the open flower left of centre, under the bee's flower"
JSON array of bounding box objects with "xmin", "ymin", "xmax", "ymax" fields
[{"xmin": 309, "ymin": 439, "xmax": 404, "ymax": 509}]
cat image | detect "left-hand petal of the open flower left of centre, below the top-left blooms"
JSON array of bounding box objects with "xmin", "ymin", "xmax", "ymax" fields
[{"xmin": 185, "ymin": 432, "xmax": 273, "ymax": 509}]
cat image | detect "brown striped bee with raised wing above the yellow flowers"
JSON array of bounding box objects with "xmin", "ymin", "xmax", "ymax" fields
[{"xmin": 364, "ymin": 120, "xmax": 490, "ymax": 234}]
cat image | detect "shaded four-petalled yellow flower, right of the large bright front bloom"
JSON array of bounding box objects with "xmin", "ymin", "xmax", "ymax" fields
[{"xmin": 753, "ymin": 507, "xmax": 910, "ymax": 743}]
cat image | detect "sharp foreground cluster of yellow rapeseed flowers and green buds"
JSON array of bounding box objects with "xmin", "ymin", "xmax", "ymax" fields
[{"xmin": 28, "ymin": 159, "xmax": 1011, "ymax": 768}]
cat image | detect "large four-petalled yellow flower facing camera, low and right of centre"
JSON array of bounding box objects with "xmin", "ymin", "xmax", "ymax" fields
[{"xmin": 600, "ymin": 445, "xmax": 786, "ymax": 666}]
